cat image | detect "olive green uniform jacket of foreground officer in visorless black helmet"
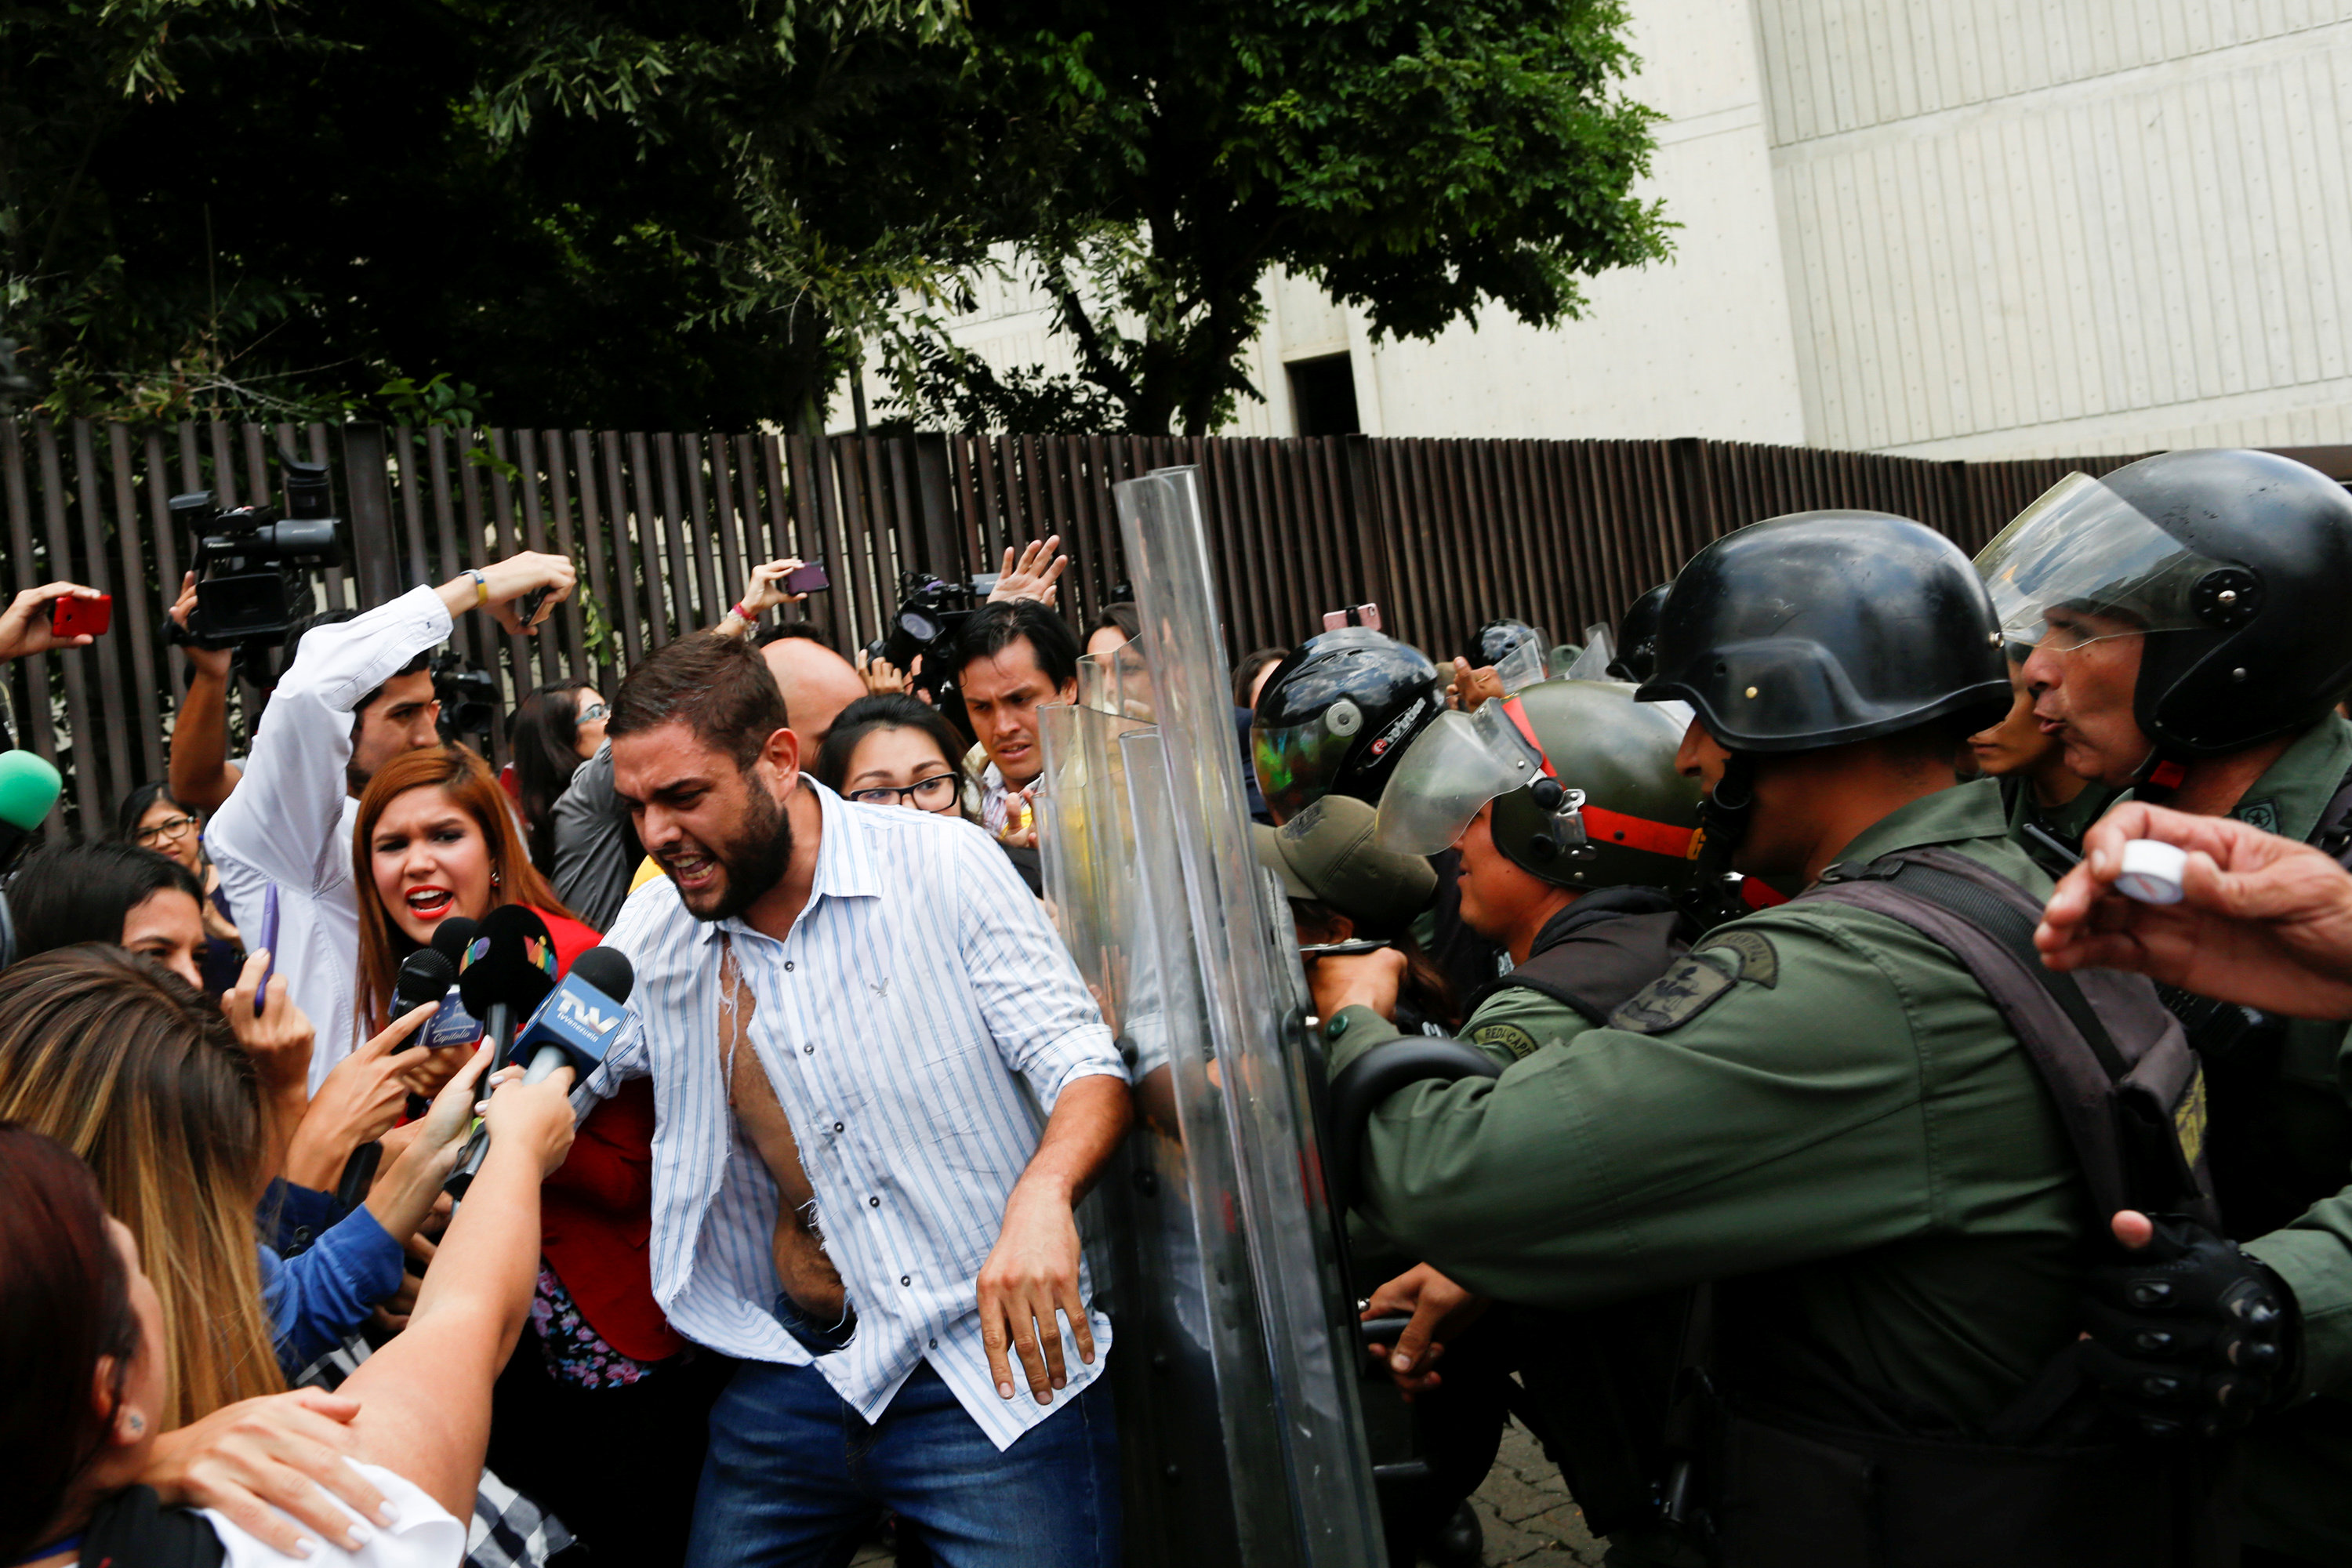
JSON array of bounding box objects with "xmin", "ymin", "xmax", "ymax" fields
[{"xmin": 1327, "ymin": 781, "xmax": 2086, "ymax": 1425}]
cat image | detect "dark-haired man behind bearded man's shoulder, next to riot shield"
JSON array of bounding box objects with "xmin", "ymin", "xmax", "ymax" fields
[{"xmin": 953, "ymin": 600, "xmax": 1080, "ymax": 844}]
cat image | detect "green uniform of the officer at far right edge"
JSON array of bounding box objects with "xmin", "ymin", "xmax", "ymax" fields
[{"xmin": 2216, "ymin": 715, "xmax": 2352, "ymax": 1561}]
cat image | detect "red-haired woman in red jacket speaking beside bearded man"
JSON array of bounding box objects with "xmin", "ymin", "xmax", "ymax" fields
[{"xmin": 350, "ymin": 746, "xmax": 722, "ymax": 1563}]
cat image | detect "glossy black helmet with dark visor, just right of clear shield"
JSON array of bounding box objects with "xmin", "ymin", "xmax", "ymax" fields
[{"xmin": 1249, "ymin": 626, "xmax": 1446, "ymax": 822}]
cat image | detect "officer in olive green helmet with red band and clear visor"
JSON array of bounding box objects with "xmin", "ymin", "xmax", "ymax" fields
[{"xmin": 1319, "ymin": 680, "xmax": 1698, "ymax": 1561}]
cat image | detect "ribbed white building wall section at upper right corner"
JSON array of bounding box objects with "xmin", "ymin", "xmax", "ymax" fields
[{"xmin": 1757, "ymin": 0, "xmax": 2352, "ymax": 456}]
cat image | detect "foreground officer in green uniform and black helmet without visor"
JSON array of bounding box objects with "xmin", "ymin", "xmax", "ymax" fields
[{"xmin": 1324, "ymin": 513, "xmax": 2213, "ymax": 1566}]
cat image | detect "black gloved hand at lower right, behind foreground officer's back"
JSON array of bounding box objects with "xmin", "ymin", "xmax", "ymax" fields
[{"xmin": 2082, "ymin": 1215, "xmax": 2303, "ymax": 1436}]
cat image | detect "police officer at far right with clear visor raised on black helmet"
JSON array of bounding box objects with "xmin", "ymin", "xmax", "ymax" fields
[{"xmin": 1978, "ymin": 452, "xmax": 2352, "ymax": 1561}]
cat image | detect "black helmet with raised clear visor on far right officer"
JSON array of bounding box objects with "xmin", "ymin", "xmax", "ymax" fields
[{"xmin": 1976, "ymin": 452, "xmax": 2352, "ymax": 760}]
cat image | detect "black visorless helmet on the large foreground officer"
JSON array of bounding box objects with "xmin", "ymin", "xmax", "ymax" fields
[{"xmin": 1639, "ymin": 513, "xmax": 2011, "ymax": 753}]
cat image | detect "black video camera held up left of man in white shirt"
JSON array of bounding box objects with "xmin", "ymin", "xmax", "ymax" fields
[{"xmin": 172, "ymin": 452, "xmax": 343, "ymax": 649}]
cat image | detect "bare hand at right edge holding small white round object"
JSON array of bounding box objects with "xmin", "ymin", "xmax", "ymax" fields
[{"xmin": 2034, "ymin": 801, "xmax": 2352, "ymax": 1018}]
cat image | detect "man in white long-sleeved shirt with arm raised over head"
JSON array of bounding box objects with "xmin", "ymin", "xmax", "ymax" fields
[{"xmin": 205, "ymin": 550, "xmax": 574, "ymax": 1088}]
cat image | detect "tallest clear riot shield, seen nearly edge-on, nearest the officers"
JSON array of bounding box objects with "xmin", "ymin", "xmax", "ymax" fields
[{"xmin": 1117, "ymin": 468, "xmax": 1383, "ymax": 1568}]
